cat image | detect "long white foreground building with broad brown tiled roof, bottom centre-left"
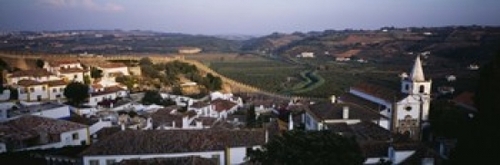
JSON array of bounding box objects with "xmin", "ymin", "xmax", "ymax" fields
[{"xmin": 81, "ymin": 129, "xmax": 267, "ymax": 165}]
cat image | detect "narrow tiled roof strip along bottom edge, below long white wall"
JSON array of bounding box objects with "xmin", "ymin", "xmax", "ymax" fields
[{"xmin": 116, "ymin": 156, "xmax": 219, "ymax": 165}]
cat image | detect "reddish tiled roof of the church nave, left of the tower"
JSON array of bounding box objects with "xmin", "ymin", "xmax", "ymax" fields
[{"xmin": 351, "ymin": 83, "xmax": 406, "ymax": 102}]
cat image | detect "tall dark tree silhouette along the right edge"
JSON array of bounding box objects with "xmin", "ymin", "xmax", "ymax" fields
[{"xmin": 450, "ymin": 49, "xmax": 500, "ymax": 164}]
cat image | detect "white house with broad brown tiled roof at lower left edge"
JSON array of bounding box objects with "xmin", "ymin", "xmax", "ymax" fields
[{"xmin": 0, "ymin": 115, "xmax": 90, "ymax": 151}]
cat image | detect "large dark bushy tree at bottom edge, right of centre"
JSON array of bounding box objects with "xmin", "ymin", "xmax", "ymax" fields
[{"xmin": 248, "ymin": 130, "xmax": 365, "ymax": 165}]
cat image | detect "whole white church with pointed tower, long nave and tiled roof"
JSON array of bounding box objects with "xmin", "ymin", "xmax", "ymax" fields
[{"xmin": 339, "ymin": 56, "xmax": 432, "ymax": 139}]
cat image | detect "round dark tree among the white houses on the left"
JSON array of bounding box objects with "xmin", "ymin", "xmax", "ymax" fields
[{"xmin": 64, "ymin": 82, "xmax": 90, "ymax": 106}]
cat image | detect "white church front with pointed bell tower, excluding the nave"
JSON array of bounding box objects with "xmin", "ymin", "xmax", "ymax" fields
[{"xmin": 392, "ymin": 56, "xmax": 432, "ymax": 139}]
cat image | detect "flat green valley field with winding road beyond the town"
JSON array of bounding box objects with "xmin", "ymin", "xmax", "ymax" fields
[{"xmin": 186, "ymin": 54, "xmax": 400, "ymax": 98}]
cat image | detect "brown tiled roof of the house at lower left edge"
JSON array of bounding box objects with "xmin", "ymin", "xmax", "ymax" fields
[{"xmin": 0, "ymin": 115, "xmax": 87, "ymax": 140}]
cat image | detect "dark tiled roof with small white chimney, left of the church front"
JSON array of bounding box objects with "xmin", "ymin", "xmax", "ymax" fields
[{"xmin": 308, "ymin": 102, "xmax": 385, "ymax": 121}]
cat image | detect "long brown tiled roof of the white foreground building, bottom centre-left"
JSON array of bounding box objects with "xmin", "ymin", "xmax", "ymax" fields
[{"xmin": 80, "ymin": 129, "xmax": 266, "ymax": 156}]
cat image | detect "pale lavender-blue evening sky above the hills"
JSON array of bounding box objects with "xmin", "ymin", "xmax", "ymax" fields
[{"xmin": 0, "ymin": 0, "xmax": 500, "ymax": 35}]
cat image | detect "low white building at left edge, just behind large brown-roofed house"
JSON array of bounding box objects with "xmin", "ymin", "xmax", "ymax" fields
[{"xmin": 0, "ymin": 102, "xmax": 71, "ymax": 122}]
